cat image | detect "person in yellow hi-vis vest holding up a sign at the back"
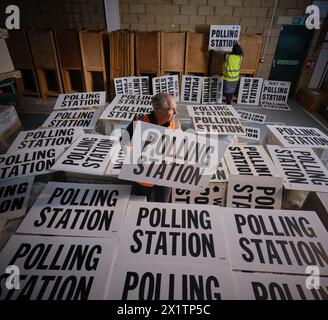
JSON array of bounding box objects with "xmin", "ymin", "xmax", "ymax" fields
[{"xmin": 214, "ymin": 42, "xmax": 243, "ymax": 104}]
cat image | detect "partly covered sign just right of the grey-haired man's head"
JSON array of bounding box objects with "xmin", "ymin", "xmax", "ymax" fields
[{"xmin": 186, "ymin": 104, "xmax": 240, "ymax": 118}]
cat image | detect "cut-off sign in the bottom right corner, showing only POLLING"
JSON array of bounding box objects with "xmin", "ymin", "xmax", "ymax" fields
[{"xmin": 233, "ymin": 266, "xmax": 328, "ymax": 300}]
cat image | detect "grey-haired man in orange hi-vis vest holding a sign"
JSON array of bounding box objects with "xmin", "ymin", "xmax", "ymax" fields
[{"xmin": 127, "ymin": 92, "xmax": 181, "ymax": 202}]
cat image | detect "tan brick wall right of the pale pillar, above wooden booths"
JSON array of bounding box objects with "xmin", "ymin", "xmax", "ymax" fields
[{"xmin": 119, "ymin": 0, "xmax": 318, "ymax": 86}]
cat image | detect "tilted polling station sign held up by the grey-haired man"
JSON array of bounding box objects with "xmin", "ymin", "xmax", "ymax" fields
[{"xmin": 119, "ymin": 121, "xmax": 227, "ymax": 191}]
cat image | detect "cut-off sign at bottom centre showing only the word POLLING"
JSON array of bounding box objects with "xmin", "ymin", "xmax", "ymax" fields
[{"xmin": 107, "ymin": 261, "xmax": 235, "ymax": 301}]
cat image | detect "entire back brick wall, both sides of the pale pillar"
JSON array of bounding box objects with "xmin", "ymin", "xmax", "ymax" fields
[{"xmin": 0, "ymin": 0, "xmax": 319, "ymax": 90}]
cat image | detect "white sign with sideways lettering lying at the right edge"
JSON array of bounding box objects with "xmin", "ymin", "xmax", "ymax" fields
[{"xmin": 267, "ymin": 145, "xmax": 328, "ymax": 192}]
